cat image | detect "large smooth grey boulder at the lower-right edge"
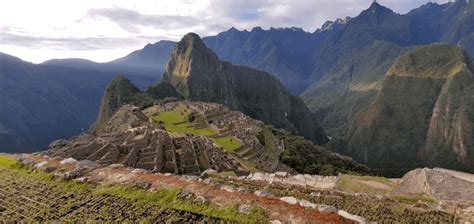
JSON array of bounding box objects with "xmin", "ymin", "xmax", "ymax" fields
[{"xmin": 393, "ymin": 168, "xmax": 474, "ymax": 203}]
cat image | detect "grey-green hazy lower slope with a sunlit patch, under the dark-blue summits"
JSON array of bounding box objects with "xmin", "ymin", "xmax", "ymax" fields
[{"xmin": 301, "ymin": 41, "xmax": 407, "ymax": 138}]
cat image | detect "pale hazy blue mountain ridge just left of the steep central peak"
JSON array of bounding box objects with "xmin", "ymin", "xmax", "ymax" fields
[{"xmin": 43, "ymin": 41, "xmax": 176, "ymax": 84}]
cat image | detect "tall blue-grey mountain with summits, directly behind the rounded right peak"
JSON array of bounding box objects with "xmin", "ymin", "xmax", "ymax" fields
[{"xmin": 301, "ymin": 1, "xmax": 474, "ymax": 138}]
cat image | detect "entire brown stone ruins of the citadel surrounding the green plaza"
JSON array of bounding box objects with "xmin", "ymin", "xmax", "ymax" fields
[{"xmin": 46, "ymin": 101, "xmax": 295, "ymax": 175}]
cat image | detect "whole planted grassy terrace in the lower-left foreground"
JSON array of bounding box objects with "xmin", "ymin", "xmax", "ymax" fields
[{"xmin": 0, "ymin": 156, "xmax": 266, "ymax": 223}]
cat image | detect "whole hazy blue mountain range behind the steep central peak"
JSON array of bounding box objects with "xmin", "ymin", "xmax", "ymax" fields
[{"xmin": 44, "ymin": 0, "xmax": 474, "ymax": 137}]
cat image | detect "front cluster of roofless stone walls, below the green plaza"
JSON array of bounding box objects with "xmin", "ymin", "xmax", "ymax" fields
[{"xmin": 46, "ymin": 127, "xmax": 243, "ymax": 175}]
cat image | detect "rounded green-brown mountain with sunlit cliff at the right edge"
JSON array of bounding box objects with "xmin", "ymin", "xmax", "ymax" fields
[{"xmin": 345, "ymin": 44, "xmax": 474, "ymax": 171}]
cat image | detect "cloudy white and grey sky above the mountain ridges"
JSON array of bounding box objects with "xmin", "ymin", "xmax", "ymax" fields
[{"xmin": 0, "ymin": 0, "xmax": 448, "ymax": 63}]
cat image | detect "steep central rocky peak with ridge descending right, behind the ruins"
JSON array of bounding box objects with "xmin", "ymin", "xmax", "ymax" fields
[{"xmin": 162, "ymin": 33, "xmax": 327, "ymax": 144}]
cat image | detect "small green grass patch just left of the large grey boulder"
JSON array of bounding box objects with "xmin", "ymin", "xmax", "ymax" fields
[{"xmin": 337, "ymin": 174, "xmax": 395, "ymax": 193}]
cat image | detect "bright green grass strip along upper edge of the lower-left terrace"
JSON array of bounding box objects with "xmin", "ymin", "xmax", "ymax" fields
[{"xmin": 0, "ymin": 156, "xmax": 266, "ymax": 223}]
